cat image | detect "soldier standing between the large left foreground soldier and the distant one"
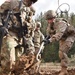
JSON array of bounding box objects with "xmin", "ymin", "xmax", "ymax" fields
[{"xmin": 24, "ymin": 6, "xmax": 35, "ymax": 55}]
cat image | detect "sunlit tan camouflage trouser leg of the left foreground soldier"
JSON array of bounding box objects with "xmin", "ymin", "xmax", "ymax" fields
[{"xmin": 1, "ymin": 36, "xmax": 17, "ymax": 73}]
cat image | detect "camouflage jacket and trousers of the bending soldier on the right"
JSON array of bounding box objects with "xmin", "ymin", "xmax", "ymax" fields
[{"xmin": 48, "ymin": 18, "xmax": 75, "ymax": 72}]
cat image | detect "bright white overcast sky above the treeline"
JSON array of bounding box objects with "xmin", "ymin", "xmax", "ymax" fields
[{"xmin": 33, "ymin": 0, "xmax": 75, "ymax": 16}]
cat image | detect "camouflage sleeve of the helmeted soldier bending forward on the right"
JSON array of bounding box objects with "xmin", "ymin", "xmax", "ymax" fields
[{"xmin": 50, "ymin": 21, "xmax": 67, "ymax": 42}]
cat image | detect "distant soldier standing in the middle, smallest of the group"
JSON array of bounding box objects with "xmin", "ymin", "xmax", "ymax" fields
[{"xmin": 33, "ymin": 22, "xmax": 44, "ymax": 72}]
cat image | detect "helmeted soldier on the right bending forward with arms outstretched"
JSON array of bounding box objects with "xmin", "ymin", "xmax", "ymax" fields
[{"xmin": 45, "ymin": 10, "xmax": 75, "ymax": 75}]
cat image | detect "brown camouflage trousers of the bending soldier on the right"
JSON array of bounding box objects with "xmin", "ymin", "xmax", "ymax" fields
[{"xmin": 59, "ymin": 36, "xmax": 75, "ymax": 68}]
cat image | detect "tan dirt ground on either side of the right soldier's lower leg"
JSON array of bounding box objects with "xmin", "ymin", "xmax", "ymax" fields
[{"xmin": 39, "ymin": 63, "xmax": 75, "ymax": 75}]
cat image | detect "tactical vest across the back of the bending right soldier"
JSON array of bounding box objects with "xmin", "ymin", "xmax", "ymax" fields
[{"xmin": 54, "ymin": 18, "xmax": 75, "ymax": 40}]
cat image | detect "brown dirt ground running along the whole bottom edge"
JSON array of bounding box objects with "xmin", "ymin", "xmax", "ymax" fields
[{"xmin": 0, "ymin": 63, "xmax": 75, "ymax": 75}]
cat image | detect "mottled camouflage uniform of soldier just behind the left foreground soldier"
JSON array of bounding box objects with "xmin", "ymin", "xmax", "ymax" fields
[{"xmin": 20, "ymin": 5, "xmax": 35, "ymax": 54}]
